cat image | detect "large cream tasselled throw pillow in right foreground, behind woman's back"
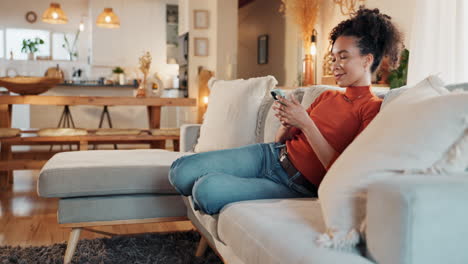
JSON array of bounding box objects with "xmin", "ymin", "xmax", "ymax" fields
[{"xmin": 318, "ymin": 76, "xmax": 468, "ymax": 250}]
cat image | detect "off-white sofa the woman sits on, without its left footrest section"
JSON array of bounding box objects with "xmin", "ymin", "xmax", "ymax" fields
[{"xmin": 181, "ymin": 84, "xmax": 468, "ymax": 264}]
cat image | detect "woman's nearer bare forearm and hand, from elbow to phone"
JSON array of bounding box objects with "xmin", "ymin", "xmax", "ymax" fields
[{"xmin": 277, "ymin": 97, "xmax": 338, "ymax": 168}]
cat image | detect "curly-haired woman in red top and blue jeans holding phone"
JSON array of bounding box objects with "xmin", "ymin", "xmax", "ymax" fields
[{"xmin": 169, "ymin": 7, "xmax": 402, "ymax": 214}]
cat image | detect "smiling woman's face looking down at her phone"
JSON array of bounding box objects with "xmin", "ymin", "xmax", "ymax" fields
[{"xmin": 331, "ymin": 36, "xmax": 373, "ymax": 87}]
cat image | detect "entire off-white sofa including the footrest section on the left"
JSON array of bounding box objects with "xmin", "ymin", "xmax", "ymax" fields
[{"xmin": 38, "ymin": 85, "xmax": 468, "ymax": 264}]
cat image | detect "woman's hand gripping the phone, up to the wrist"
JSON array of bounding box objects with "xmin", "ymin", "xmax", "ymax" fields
[{"xmin": 273, "ymin": 95, "xmax": 312, "ymax": 129}]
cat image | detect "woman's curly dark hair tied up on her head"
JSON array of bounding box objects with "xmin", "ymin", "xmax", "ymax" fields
[{"xmin": 330, "ymin": 6, "xmax": 403, "ymax": 72}]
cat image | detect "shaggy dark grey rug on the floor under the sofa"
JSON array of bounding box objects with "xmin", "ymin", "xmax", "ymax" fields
[{"xmin": 0, "ymin": 231, "xmax": 222, "ymax": 264}]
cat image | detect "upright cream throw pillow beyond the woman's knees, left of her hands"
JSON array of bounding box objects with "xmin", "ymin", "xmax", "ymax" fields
[{"xmin": 195, "ymin": 76, "xmax": 278, "ymax": 152}]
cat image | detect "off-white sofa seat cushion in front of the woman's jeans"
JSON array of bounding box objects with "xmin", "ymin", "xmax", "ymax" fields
[{"xmin": 218, "ymin": 198, "xmax": 372, "ymax": 264}]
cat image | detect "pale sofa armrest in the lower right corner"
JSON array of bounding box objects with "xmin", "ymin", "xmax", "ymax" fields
[{"xmin": 366, "ymin": 173, "xmax": 468, "ymax": 264}]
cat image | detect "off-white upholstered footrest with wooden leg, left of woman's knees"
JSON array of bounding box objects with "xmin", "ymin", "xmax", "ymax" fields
[{"xmin": 37, "ymin": 149, "xmax": 192, "ymax": 263}]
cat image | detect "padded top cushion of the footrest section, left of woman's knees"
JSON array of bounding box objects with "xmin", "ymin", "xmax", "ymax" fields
[{"xmin": 38, "ymin": 149, "xmax": 190, "ymax": 197}]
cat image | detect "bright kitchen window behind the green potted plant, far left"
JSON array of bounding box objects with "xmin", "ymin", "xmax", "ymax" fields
[{"xmin": 6, "ymin": 28, "xmax": 50, "ymax": 60}]
